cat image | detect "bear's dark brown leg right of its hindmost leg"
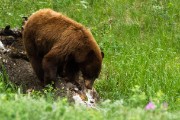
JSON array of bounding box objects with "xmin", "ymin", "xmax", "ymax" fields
[{"xmin": 43, "ymin": 55, "xmax": 58, "ymax": 87}]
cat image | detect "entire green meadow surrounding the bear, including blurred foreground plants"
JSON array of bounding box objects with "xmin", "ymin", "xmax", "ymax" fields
[{"xmin": 0, "ymin": 0, "xmax": 180, "ymax": 120}]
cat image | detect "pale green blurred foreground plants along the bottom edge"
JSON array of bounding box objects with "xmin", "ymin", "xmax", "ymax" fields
[{"xmin": 0, "ymin": 94, "xmax": 178, "ymax": 120}]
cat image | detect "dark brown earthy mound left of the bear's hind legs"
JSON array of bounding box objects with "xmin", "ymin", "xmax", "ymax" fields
[{"xmin": 0, "ymin": 28, "xmax": 42, "ymax": 91}]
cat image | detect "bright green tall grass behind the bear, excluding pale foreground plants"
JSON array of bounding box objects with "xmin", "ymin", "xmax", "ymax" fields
[{"xmin": 0, "ymin": 0, "xmax": 180, "ymax": 118}]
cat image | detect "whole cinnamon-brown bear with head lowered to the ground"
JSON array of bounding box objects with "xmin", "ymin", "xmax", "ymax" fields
[{"xmin": 23, "ymin": 9, "xmax": 104, "ymax": 89}]
